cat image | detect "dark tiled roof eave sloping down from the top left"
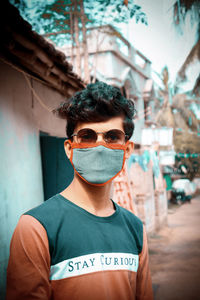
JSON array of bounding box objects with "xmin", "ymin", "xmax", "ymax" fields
[{"xmin": 0, "ymin": 1, "xmax": 85, "ymax": 97}]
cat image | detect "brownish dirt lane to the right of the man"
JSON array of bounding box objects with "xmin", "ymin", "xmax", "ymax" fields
[{"xmin": 149, "ymin": 196, "xmax": 200, "ymax": 300}]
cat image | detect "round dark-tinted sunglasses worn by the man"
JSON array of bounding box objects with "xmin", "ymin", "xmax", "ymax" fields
[{"xmin": 72, "ymin": 128, "xmax": 128, "ymax": 145}]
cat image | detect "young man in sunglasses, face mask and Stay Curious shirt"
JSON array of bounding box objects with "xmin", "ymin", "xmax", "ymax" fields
[{"xmin": 7, "ymin": 82, "xmax": 153, "ymax": 300}]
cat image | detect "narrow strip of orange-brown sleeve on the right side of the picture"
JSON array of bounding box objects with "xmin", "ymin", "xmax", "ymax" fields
[{"xmin": 136, "ymin": 226, "xmax": 153, "ymax": 300}]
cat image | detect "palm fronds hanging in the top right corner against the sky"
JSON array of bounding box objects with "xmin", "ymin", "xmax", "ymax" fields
[{"xmin": 173, "ymin": 0, "xmax": 200, "ymax": 96}]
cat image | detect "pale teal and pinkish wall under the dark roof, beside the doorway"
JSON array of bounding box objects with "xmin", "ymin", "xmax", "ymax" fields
[{"xmin": 0, "ymin": 62, "xmax": 65, "ymax": 299}]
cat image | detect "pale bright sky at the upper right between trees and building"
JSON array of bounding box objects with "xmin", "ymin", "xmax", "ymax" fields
[{"xmin": 119, "ymin": 0, "xmax": 200, "ymax": 91}]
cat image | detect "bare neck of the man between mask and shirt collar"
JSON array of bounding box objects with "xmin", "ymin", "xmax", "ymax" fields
[{"xmin": 61, "ymin": 175, "xmax": 114, "ymax": 216}]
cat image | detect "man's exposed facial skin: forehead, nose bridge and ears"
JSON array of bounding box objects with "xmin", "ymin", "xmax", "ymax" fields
[{"xmin": 65, "ymin": 116, "xmax": 133, "ymax": 159}]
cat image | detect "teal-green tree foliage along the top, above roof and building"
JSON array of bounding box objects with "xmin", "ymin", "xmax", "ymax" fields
[{"xmin": 10, "ymin": 0, "xmax": 147, "ymax": 45}]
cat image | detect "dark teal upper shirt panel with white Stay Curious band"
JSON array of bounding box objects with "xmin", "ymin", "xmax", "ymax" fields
[{"xmin": 25, "ymin": 194, "xmax": 143, "ymax": 280}]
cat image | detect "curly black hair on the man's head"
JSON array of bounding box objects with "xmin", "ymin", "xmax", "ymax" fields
[{"xmin": 54, "ymin": 81, "xmax": 135, "ymax": 139}]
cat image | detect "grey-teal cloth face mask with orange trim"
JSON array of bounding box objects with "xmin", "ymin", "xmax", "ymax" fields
[{"xmin": 70, "ymin": 142, "xmax": 127, "ymax": 186}]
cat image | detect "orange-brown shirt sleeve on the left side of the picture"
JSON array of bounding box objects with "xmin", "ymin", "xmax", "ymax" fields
[{"xmin": 6, "ymin": 215, "xmax": 51, "ymax": 300}]
